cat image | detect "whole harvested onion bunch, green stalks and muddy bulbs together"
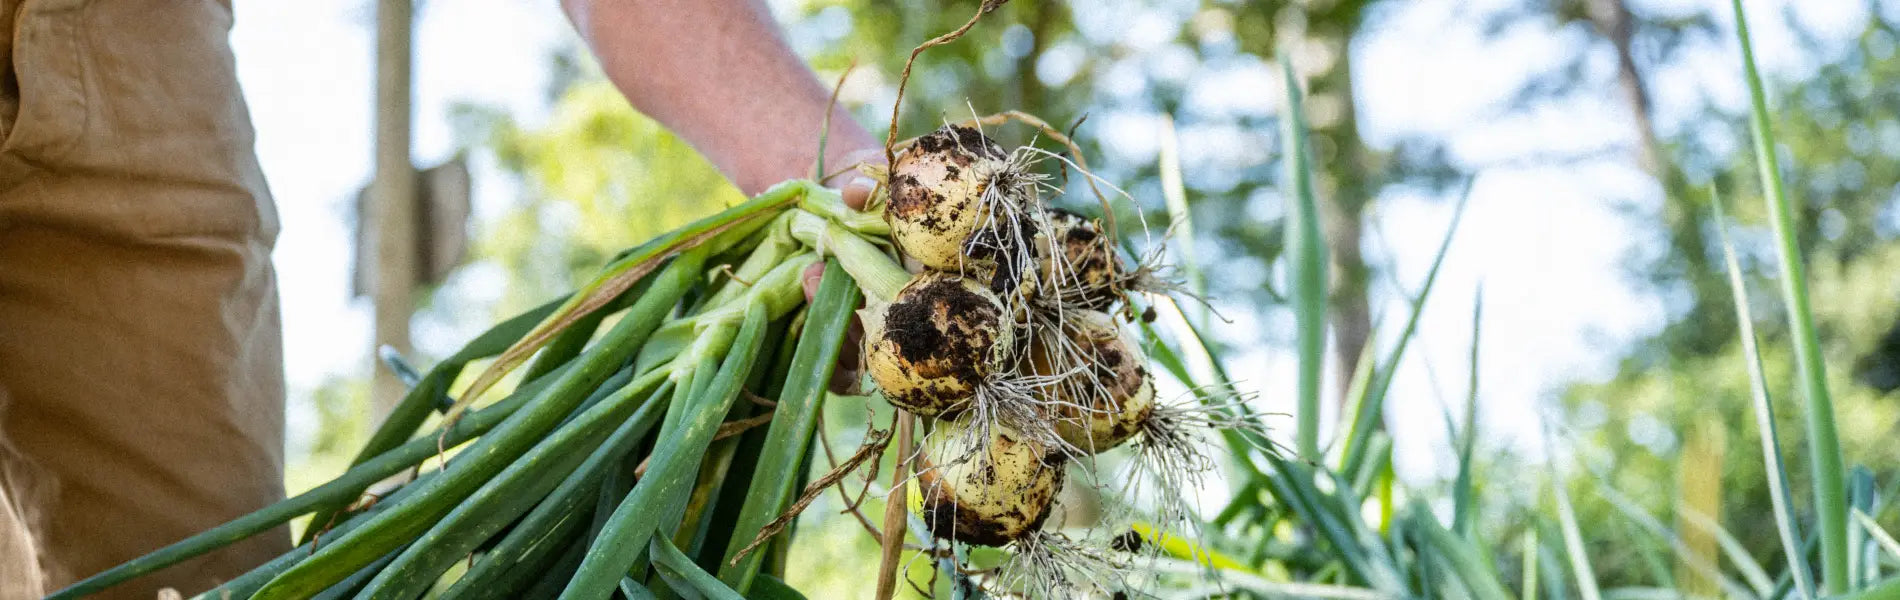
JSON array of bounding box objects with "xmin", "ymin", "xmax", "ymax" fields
[{"xmin": 53, "ymin": 125, "xmax": 1246, "ymax": 598}]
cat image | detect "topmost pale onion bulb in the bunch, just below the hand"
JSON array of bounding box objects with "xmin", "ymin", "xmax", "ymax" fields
[{"xmin": 885, "ymin": 125, "xmax": 1009, "ymax": 272}]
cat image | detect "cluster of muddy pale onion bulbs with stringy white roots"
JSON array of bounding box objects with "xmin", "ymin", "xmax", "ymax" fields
[{"xmin": 865, "ymin": 125, "xmax": 1252, "ymax": 594}]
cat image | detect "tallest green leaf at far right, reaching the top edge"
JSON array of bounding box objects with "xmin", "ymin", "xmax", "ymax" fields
[{"xmin": 1731, "ymin": 0, "xmax": 1851, "ymax": 594}]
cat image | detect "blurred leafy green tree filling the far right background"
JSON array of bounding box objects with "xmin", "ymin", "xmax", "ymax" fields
[{"xmin": 1562, "ymin": 4, "xmax": 1900, "ymax": 583}]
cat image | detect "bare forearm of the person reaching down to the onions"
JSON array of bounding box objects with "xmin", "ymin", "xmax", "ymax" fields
[{"xmin": 562, "ymin": 0, "xmax": 882, "ymax": 194}]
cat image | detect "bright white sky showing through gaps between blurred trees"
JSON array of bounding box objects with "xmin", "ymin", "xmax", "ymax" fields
[{"xmin": 232, "ymin": 0, "xmax": 1866, "ymax": 478}]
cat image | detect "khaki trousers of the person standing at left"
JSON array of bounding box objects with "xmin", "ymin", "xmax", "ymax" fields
[{"xmin": 0, "ymin": 0, "xmax": 289, "ymax": 600}]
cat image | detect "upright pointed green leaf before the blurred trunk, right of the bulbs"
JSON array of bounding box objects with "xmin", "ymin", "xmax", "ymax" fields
[{"xmin": 1281, "ymin": 53, "xmax": 1326, "ymax": 461}]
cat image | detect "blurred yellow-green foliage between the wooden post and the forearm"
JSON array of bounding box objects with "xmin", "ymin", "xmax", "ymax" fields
[{"xmin": 458, "ymin": 75, "xmax": 745, "ymax": 315}]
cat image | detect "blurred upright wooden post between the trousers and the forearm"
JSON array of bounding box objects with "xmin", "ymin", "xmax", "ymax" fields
[{"xmin": 363, "ymin": 0, "xmax": 416, "ymax": 420}]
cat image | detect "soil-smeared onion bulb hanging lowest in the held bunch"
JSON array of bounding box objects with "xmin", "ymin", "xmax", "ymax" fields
[{"xmin": 910, "ymin": 420, "xmax": 1062, "ymax": 547}]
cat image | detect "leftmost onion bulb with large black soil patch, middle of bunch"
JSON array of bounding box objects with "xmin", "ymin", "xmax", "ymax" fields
[{"xmin": 865, "ymin": 272, "xmax": 1015, "ymax": 416}]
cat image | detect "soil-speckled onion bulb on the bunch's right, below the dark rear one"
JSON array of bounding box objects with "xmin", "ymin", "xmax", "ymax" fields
[{"xmin": 1030, "ymin": 309, "xmax": 1155, "ymax": 452}]
